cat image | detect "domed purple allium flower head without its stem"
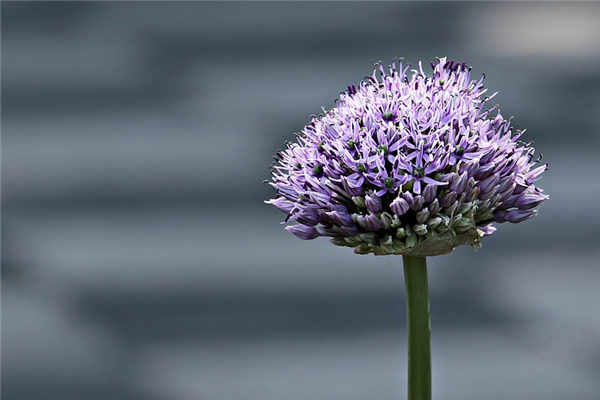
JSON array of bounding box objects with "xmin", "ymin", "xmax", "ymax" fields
[{"xmin": 267, "ymin": 58, "xmax": 548, "ymax": 256}]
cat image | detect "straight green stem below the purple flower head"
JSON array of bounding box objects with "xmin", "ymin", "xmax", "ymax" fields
[{"xmin": 403, "ymin": 256, "xmax": 431, "ymax": 400}]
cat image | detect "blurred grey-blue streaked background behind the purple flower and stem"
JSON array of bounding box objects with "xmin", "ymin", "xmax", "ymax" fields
[{"xmin": 2, "ymin": 2, "xmax": 600, "ymax": 400}]
